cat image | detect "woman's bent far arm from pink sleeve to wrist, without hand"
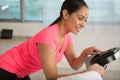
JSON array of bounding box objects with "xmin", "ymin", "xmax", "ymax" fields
[{"xmin": 65, "ymin": 44, "xmax": 88, "ymax": 70}]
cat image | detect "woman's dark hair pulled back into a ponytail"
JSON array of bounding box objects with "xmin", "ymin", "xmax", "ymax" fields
[{"xmin": 51, "ymin": 0, "xmax": 88, "ymax": 25}]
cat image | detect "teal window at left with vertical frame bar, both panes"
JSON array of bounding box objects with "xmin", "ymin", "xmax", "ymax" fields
[{"xmin": 0, "ymin": 0, "xmax": 44, "ymax": 21}]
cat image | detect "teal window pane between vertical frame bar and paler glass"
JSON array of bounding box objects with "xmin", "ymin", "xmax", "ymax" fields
[{"xmin": 24, "ymin": 0, "xmax": 44, "ymax": 21}]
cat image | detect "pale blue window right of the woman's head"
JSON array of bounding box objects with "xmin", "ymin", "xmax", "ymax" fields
[{"xmin": 86, "ymin": 0, "xmax": 120, "ymax": 23}]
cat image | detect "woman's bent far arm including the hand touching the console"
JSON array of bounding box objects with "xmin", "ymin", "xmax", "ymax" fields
[{"xmin": 65, "ymin": 44, "xmax": 103, "ymax": 70}]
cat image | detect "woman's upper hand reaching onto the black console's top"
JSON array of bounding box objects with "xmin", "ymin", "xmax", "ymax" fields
[{"xmin": 83, "ymin": 46, "xmax": 102, "ymax": 55}]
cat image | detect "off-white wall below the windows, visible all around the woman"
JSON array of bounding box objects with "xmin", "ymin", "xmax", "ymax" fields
[{"xmin": 0, "ymin": 22, "xmax": 120, "ymax": 70}]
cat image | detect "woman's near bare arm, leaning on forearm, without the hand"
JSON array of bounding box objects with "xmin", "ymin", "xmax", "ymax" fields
[{"xmin": 38, "ymin": 43, "xmax": 104, "ymax": 80}]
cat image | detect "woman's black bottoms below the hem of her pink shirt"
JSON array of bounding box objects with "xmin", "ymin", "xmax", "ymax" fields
[{"xmin": 0, "ymin": 68, "xmax": 30, "ymax": 80}]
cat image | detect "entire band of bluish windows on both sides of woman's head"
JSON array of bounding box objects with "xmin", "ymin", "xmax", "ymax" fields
[{"xmin": 0, "ymin": 0, "xmax": 120, "ymax": 24}]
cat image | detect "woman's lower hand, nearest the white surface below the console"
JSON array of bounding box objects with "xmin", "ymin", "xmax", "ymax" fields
[{"xmin": 88, "ymin": 64, "xmax": 105, "ymax": 77}]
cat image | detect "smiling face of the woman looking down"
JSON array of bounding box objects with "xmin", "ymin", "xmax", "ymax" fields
[{"xmin": 65, "ymin": 7, "xmax": 88, "ymax": 34}]
